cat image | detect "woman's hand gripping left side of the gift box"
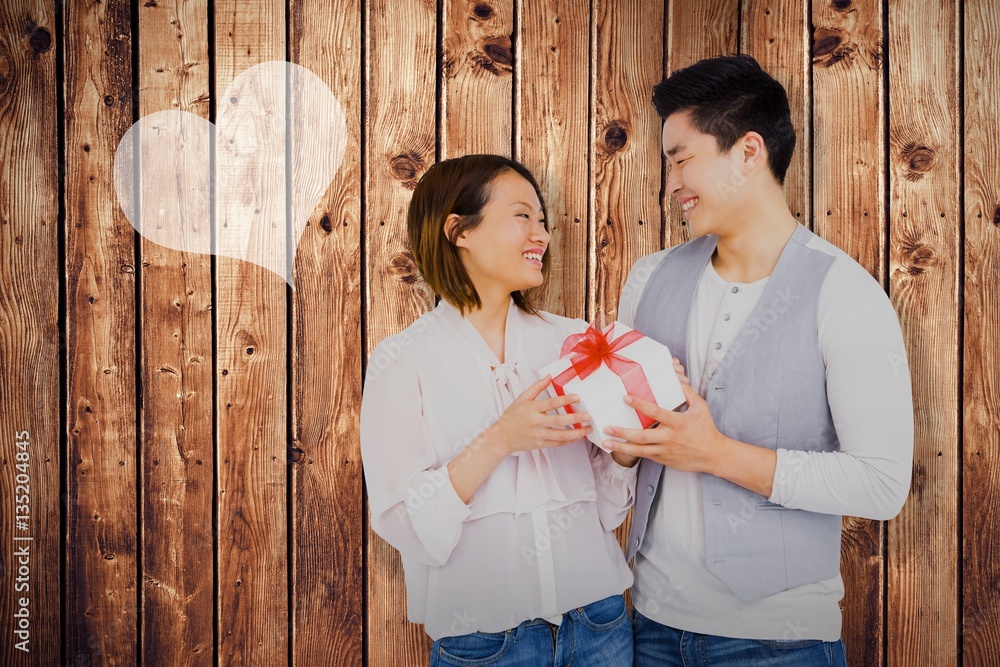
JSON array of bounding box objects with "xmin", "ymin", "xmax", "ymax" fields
[{"xmin": 490, "ymin": 375, "xmax": 593, "ymax": 454}]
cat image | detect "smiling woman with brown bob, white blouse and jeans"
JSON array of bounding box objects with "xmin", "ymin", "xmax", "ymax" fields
[{"xmin": 361, "ymin": 155, "xmax": 635, "ymax": 667}]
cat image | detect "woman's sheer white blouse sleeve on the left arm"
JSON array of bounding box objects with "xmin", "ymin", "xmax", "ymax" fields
[{"xmin": 361, "ymin": 341, "xmax": 475, "ymax": 566}]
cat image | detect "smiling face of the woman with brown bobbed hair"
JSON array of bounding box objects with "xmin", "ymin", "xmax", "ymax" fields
[{"xmin": 455, "ymin": 171, "xmax": 549, "ymax": 294}]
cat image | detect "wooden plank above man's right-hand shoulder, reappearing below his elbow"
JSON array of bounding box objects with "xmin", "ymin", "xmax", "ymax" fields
[{"xmin": 803, "ymin": 0, "xmax": 886, "ymax": 664}]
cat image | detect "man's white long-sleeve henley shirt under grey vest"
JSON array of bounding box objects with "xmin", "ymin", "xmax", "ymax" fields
[{"xmin": 618, "ymin": 237, "xmax": 913, "ymax": 641}]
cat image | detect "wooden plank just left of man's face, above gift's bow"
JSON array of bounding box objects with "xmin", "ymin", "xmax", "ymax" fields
[{"xmin": 587, "ymin": 0, "xmax": 664, "ymax": 324}]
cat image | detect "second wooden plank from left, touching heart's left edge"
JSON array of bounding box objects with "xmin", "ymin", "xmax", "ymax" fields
[{"xmin": 63, "ymin": 0, "xmax": 139, "ymax": 665}]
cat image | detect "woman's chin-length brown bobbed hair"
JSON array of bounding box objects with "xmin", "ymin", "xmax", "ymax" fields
[{"xmin": 406, "ymin": 155, "xmax": 549, "ymax": 315}]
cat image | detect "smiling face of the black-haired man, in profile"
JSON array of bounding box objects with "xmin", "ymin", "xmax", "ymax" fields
[{"xmin": 663, "ymin": 107, "xmax": 746, "ymax": 238}]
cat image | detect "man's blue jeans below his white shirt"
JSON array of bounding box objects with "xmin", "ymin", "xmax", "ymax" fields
[{"xmin": 632, "ymin": 611, "xmax": 847, "ymax": 667}]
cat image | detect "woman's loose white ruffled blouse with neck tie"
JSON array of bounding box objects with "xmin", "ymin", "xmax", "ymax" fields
[{"xmin": 361, "ymin": 299, "xmax": 636, "ymax": 639}]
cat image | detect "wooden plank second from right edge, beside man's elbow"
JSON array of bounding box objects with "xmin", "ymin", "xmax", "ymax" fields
[{"xmin": 892, "ymin": 0, "xmax": 962, "ymax": 665}]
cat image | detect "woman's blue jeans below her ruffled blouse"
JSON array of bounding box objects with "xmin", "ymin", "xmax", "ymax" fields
[{"xmin": 430, "ymin": 595, "xmax": 632, "ymax": 667}]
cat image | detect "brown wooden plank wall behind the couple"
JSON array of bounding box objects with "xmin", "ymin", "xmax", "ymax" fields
[{"xmin": 0, "ymin": 0, "xmax": 1000, "ymax": 666}]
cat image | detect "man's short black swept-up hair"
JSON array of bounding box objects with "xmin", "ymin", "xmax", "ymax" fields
[{"xmin": 653, "ymin": 55, "xmax": 795, "ymax": 184}]
